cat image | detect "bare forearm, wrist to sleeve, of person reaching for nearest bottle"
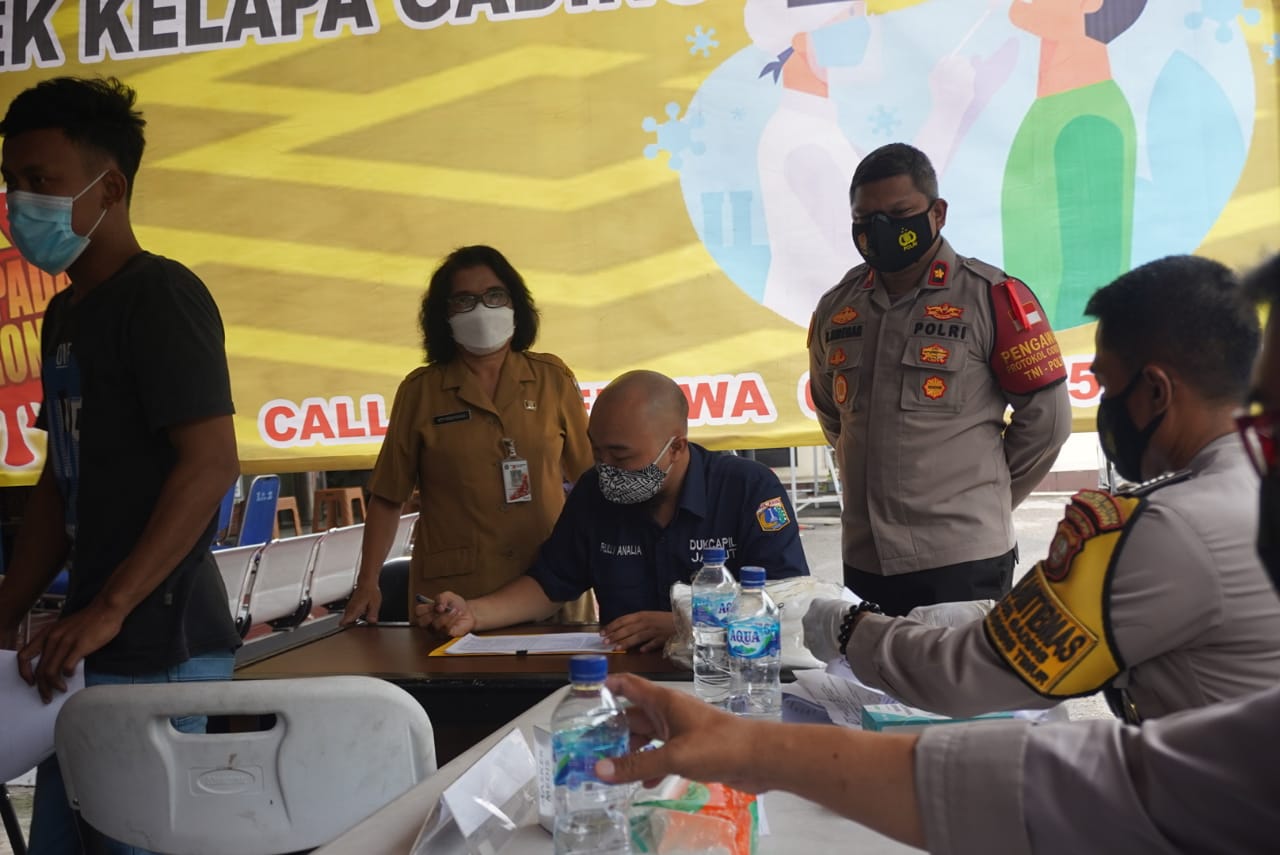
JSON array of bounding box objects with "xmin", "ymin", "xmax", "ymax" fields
[{"xmin": 752, "ymin": 724, "xmax": 924, "ymax": 846}]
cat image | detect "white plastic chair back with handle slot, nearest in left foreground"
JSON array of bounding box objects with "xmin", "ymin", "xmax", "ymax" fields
[{"xmin": 56, "ymin": 677, "xmax": 435, "ymax": 855}]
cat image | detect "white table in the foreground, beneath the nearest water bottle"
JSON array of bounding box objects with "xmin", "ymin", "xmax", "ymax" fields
[{"xmin": 316, "ymin": 683, "xmax": 920, "ymax": 855}]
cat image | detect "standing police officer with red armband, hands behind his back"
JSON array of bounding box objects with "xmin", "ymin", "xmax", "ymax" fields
[{"xmin": 809, "ymin": 143, "xmax": 1070, "ymax": 614}]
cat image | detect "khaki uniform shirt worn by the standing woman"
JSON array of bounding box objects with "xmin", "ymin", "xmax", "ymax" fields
[{"xmin": 369, "ymin": 352, "xmax": 593, "ymax": 619}]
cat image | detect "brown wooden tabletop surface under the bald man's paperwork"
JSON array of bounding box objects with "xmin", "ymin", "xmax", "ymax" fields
[{"xmin": 236, "ymin": 623, "xmax": 691, "ymax": 685}]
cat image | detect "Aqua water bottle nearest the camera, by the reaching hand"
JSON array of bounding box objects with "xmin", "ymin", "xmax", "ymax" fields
[{"xmin": 552, "ymin": 655, "xmax": 631, "ymax": 855}]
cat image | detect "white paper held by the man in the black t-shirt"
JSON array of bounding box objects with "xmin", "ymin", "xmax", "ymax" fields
[{"xmin": 0, "ymin": 650, "xmax": 84, "ymax": 783}]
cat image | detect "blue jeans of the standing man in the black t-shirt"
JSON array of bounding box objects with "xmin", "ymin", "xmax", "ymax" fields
[{"xmin": 27, "ymin": 650, "xmax": 236, "ymax": 855}]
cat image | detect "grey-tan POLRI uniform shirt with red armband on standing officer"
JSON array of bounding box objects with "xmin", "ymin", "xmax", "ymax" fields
[{"xmin": 809, "ymin": 241, "xmax": 1071, "ymax": 576}]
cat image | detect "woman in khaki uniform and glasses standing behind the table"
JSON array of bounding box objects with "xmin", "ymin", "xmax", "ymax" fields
[{"xmin": 343, "ymin": 246, "xmax": 595, "ymax": 623}]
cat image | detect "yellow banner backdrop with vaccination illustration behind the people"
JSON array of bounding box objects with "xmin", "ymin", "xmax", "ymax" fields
[{"xmin": 0, "ymin": 0, "xmax": 1280, "ymax": 484}]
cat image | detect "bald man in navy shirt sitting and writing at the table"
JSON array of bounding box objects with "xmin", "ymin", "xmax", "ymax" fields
[{"xmin": 430, "ymin": 371, "xmax": 809, "ymax": 650}]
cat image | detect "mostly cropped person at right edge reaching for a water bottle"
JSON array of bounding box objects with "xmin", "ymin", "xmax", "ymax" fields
[{"xmin": 596, "ymin": 250, "xmax": 1280, "ymax": 855}]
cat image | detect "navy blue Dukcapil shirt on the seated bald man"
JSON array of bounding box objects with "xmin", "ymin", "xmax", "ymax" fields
[{"xmin": 529, "ymin": 443, "xmax": 809, "ymax": 623}]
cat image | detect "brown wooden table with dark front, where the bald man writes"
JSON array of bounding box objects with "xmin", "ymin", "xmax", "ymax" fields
[{"xmin": 236, "ymin": 623, "xmax": 692, "ymax": 765}]
